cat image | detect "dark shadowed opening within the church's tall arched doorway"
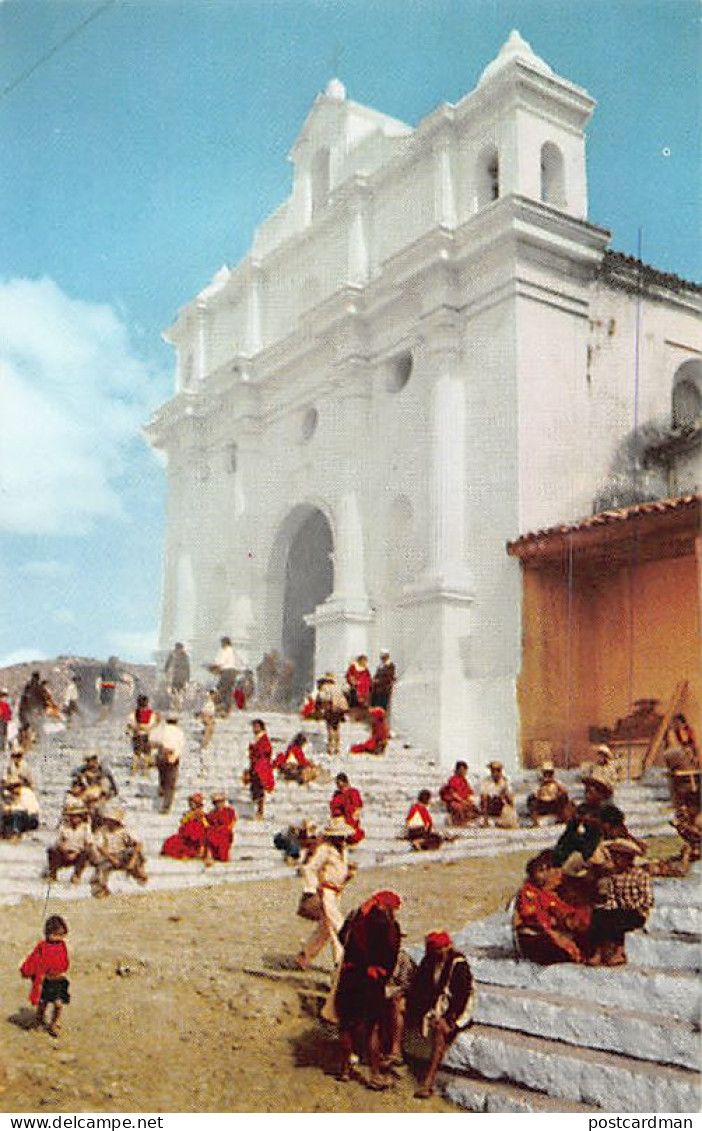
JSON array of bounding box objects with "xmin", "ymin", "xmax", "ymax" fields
[{"xmin": 281, "ymin": 507, "xmax": 333, "ymax": 699}]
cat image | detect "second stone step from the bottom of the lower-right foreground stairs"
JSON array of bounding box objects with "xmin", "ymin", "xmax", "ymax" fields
[{"xmin": 445, "ymin": 1025, "xmax": 700, "ymax": 1113}]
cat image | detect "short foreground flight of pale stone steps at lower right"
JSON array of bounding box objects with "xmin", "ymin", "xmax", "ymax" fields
[{"xmin": 431, "ymin": 871, "xmax": 702, "ymax": 1113}]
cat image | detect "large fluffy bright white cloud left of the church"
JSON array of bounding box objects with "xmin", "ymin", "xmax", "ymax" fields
[{"xmin": 0, "ymin": 278, "xmax": 164, "ymax": 534}]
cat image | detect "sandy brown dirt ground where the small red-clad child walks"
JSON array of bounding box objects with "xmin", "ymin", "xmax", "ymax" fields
[{"xmin": 0, "ymin": 856, "xmax": 535, "ymax": 1113}]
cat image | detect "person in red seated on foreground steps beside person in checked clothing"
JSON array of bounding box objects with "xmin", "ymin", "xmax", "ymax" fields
[{"xmin": 513, "ymin": 849, "xmax": 591, "ymax": 966}]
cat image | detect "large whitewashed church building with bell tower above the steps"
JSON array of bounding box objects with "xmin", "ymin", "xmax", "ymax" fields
[{"xmin": 147, "ymin": 33, "xmax": 702, "ymax": 766}]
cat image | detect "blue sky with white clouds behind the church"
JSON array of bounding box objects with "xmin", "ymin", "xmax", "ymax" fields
[{"xmin": 0, "ymin": 0, "xmax": 702, "ymax": 663}]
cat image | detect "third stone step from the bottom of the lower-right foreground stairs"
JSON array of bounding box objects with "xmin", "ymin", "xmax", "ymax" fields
[{"xmin": 475, "ymin": 979, "xmax": 700, "ymax": 1069}]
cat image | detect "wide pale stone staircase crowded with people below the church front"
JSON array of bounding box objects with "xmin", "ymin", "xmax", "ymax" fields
[{"xmin": 0, "ymin": 713, "xmax": 670, "ymax": 903}]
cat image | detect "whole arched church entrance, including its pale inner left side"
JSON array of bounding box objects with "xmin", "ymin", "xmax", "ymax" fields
[{"xmin": 270, "ymin": 503, "xmax": 333, "ymax": 699}]
